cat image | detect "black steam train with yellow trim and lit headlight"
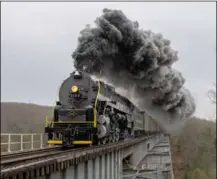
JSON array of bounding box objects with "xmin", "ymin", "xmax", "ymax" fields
[{"xmin": 45, "ymin": 71, "xmax": 158, "ymax": 147}]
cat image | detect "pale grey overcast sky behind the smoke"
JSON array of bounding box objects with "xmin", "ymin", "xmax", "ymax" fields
[{"xmin": 1, "ymin": 2, "xmax": 216, "ymax": 117}]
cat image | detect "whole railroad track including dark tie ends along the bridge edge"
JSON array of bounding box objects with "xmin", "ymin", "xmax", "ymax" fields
[{"xmin": 0, "ymin": 135, "xmax": 155, "ymax": 179}]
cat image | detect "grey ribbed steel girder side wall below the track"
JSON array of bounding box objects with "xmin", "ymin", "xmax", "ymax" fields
[{"xmin": 40, "ymin": 151, "xmax": 122, "ymax": 179}]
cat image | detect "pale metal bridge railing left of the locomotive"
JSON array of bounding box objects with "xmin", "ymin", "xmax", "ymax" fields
[{"xmin": 1, "ymin": 133, "xmax": 48, "ymax": 153}]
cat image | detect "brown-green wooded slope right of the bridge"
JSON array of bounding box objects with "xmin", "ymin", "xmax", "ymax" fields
[{"xmin": 171, "ymin": 118, "xmax": 216, "ymax": 179}]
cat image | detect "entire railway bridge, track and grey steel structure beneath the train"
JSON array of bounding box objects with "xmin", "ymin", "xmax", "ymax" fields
[{"xmin": 1, "ymin": 135, "xmax": 173, "ymax": 179}]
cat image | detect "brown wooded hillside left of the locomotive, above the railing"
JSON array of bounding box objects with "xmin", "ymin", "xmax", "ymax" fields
[{"xmin": 1, "ymin": 103, "xmax": 53, "ymax": 133}]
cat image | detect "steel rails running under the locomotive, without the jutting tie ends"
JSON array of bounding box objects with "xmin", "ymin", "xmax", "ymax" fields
[{"xmin": 1, "ymin": 136, "xmax": 151, "ymax": 172}]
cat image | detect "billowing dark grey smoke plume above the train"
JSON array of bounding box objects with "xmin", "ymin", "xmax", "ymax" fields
[{"xmin": 72, "ymin": 9, "xmax": 195, "ymax": 131}]
